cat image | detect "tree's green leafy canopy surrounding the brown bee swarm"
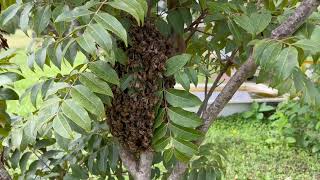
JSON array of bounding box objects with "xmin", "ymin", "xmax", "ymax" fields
[{"xmin": 0, "ymin": 0, "xmax": 320, "ymax": 179}]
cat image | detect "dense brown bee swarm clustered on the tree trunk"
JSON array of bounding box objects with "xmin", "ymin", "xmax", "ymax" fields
[{"xmin": 107, "ymin": 20, "xmax": 175, "ymax": 153}]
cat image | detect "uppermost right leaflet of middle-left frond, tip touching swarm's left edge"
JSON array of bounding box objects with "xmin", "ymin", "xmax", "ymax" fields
[{"xmin": 89, "ymin": 60, "xmax": 120, "ymax": 86}]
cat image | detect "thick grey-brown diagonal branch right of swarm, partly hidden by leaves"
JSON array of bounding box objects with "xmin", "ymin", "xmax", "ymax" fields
[{"xmin": 168, "ymin": 0, "xmax": 320, "ymax": 180}]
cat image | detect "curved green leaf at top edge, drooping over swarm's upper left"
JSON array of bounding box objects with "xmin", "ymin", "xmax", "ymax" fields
[{"xmin": 108, "ymin": 0, "xmax": 144, "ymax": 26}]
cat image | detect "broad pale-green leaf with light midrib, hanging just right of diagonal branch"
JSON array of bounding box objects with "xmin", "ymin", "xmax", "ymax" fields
[{"xmin": 276, "ymin": 47, "xmax": 299, "ymax": 79}]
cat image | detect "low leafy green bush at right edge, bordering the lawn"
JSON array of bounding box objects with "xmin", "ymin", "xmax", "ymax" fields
[{"xmin": 267, "ymin": 101, "xmax": 320, "ymax": 153}]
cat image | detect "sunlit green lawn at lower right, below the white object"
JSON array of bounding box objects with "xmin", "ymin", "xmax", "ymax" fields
[{"xmin": 206, "ymin": 116, "xmax": 320, "ymax": 180}]
